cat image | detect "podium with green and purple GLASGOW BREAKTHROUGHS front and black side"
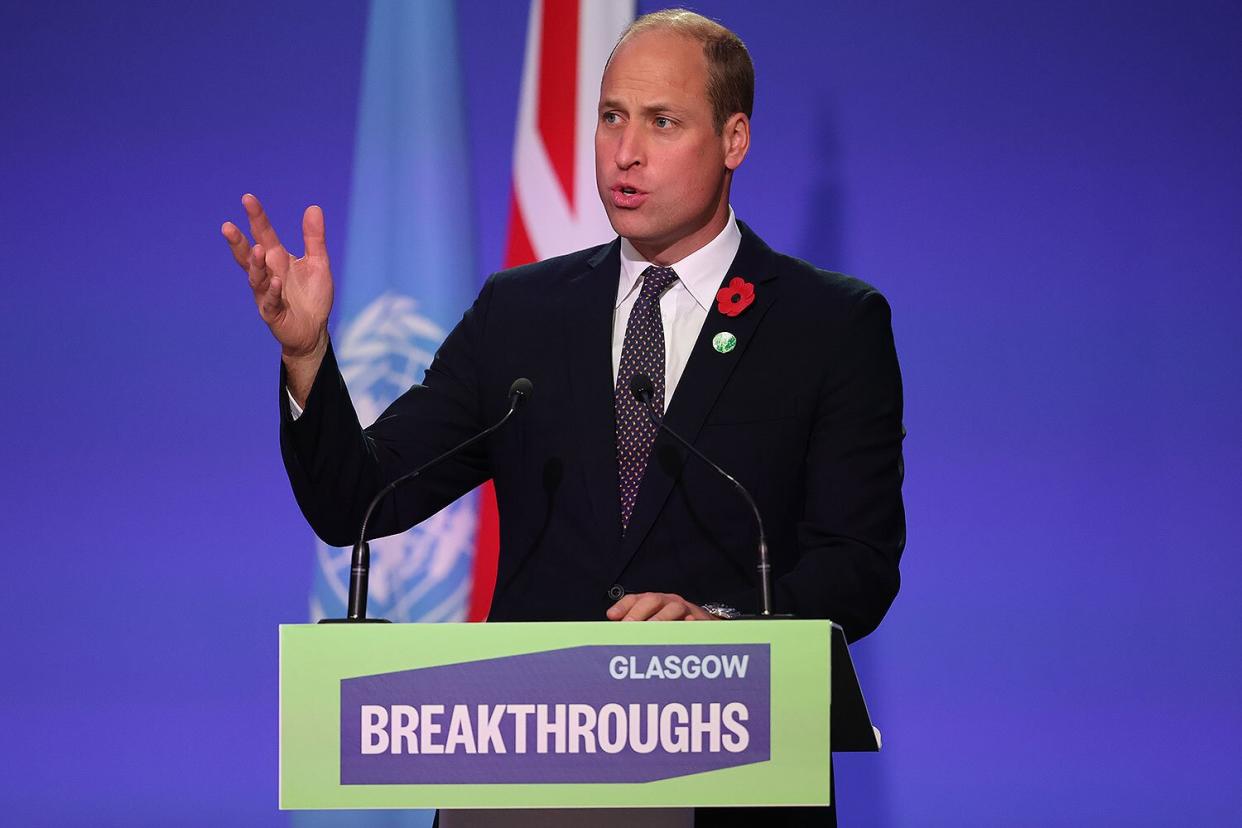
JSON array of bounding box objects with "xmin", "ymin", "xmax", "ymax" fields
[{"xmin": 279, "ymin": 619, "xmax": 879, "ymax": 809}]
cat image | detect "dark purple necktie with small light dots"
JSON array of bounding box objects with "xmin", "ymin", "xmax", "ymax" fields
[{"xmin": 615, "ymin": 264, "xmax": 677, "ymax": 535}]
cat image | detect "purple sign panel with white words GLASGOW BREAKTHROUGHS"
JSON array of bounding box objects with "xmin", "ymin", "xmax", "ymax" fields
[{"xmin": 340, "ymin": 644, "xmax": 771, "ymax": 785}]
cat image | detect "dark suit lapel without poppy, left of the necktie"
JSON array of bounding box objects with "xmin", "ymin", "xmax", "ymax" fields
[{"xmin": 564, "ymin": 240, "xmax": 621, "ymax": 549}]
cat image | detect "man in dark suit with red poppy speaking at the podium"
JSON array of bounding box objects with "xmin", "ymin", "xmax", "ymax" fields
[{"xmin": 222, "ymin": 10, "xmax": 904, "ymax": 824}]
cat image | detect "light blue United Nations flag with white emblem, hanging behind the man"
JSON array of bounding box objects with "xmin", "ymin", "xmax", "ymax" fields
[{"xmin": 311, "ymin": 0, "xmax": 478, "ymax": 621}]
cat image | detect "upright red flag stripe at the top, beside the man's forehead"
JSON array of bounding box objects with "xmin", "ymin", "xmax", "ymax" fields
[{"xmin": 532, "ymin": 0, "xmax": 579, "ymax": 211}]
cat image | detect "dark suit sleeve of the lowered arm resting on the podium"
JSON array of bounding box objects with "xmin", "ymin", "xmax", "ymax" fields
[{"xmin": 720, "ymin": 290, "xmax": 905, "ymax": 641}]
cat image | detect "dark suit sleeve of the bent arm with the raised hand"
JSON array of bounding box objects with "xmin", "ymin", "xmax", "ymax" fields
[{"xmin": 279, "ymin": 281, "xmax": 492, "ymax": 546}]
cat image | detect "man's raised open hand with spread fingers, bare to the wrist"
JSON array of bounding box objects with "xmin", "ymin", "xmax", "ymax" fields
[{"xmin": 220, "ymin": 194, "xmax": 332, "ymax": 403}]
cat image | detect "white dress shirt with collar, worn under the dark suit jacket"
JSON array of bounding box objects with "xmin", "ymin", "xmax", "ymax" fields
[{"xmin": 286, "ymin": 207, "xmax": 741, "ymax": 420}]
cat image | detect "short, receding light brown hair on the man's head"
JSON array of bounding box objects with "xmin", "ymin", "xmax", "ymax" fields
[{"xmin": 609, "ymin": 9, "xmax": 755, "ymax": 133}]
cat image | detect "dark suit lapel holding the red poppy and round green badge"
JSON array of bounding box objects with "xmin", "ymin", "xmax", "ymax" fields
[{"xmin": 610, "ymin": 222, "xmax": 776, "ymax": 576}]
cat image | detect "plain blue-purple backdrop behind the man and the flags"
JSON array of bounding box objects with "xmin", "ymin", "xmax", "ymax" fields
[{"xmin": 0, "ymin": 0, "xmax": 1242, "ymax": 826}]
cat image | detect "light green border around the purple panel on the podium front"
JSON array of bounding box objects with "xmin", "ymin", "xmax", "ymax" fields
[{"xmin": 279, "ymin": 621, "xmax": 831, "ymax": 809}]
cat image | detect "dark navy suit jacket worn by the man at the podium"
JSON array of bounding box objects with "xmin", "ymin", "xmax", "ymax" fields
[{"xmin": 281, "ymin": 219, "xmax": 905, "ymax": 639}]
